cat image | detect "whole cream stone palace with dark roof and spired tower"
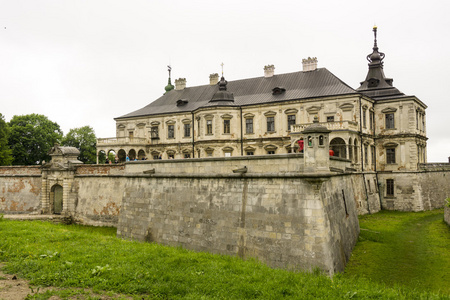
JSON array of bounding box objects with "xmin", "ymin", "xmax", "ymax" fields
[{"xmin": 97, "ymin": 27, "xmax": 427, "ymax": 176}]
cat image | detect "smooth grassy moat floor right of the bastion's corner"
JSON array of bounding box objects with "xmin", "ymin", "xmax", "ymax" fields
[{"xmin": 344, "ymin": 209, "xmax": 450, "ymax": 294}]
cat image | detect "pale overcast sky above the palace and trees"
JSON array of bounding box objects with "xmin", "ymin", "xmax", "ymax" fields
[{"xmin": 0, "ymin": 0, "xmax": 450, "ymax": 162}]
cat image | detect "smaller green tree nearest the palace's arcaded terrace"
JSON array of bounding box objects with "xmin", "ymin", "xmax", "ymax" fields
[{"xmin": 62, "ymin": 126, "xmax": 97, "ymax": 164}]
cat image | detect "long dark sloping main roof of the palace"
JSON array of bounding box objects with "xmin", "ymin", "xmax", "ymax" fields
[{"xmin": 116, "ymin": 68, "xmax": 356, "ymax": 119}]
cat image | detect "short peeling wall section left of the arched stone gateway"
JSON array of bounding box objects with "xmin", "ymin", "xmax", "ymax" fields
[{"xmin": 0, "ymin": 166, "xmax": 42, "ymax": 214}]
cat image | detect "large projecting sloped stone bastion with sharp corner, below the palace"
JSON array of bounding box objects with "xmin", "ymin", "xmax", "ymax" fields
[{"xmin": 118, "ymin": 175, "xmax": 359, "ymax": 273}]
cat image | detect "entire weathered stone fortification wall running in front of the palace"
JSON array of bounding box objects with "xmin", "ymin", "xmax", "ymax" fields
[{"xmin": 0, "ymin": 154, "xmax": 450, "ymax": 273}]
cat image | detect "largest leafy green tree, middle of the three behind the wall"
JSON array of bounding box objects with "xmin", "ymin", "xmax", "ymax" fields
[{"xmin": 8, "ymin": 114, "xmax": 63, "ymax": 165}]
